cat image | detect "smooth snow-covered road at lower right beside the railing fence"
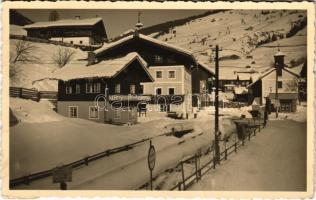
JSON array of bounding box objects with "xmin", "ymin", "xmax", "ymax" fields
[{"xmin": 191, "ymin": 120, "xmax": 307, "ymax": 191}]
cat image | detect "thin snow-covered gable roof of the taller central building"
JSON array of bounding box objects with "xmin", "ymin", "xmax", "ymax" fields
[{"xmin": 94, "ymin": 34, "xmax": 193, "ymax": 56}]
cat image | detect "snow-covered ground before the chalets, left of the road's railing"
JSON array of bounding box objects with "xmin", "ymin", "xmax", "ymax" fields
[{"xmin": 10, "ymin": 98, "xmax": 306, "ymax": 189}]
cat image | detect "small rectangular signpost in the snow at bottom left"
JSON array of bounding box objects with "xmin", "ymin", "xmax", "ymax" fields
[{"xmin": 53, "ymin": 166, "xmax": 72, "ymax": 190}]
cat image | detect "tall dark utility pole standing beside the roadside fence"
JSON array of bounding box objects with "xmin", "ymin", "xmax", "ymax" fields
[{"xmin": 213, "ymin": 45, "xmax": 221, "ymax": 164}]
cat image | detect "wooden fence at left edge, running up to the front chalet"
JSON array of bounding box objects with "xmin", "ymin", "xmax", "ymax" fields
[{"xmin": 9, "ymin": 87, "xmax": 57, "ymax": 101}]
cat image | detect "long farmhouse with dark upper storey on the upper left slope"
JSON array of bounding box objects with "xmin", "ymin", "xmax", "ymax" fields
[{"xmin": 24, "ymin": 16, "xmax": 107, "ymax": 45}]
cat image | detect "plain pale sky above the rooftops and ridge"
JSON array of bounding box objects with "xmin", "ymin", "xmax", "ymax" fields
[{"xmin": 18, "ymin": 9, "xmax": 206, "ymax": 38}]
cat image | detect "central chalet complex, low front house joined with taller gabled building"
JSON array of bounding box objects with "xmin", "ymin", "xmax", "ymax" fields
[{"xmin": 55, "ymin": 31, "xmax": 214, "ymax": 123}]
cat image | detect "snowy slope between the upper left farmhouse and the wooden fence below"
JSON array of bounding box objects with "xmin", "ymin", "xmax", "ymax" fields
[{"xmin": 10, "ymin": 39, "xmax": 87, "ymax": 91}]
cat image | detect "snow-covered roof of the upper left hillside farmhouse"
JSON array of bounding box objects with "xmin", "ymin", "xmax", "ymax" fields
[{"xmin": 24, "ymin": 17, "xmax": 103, "ymax": 29}]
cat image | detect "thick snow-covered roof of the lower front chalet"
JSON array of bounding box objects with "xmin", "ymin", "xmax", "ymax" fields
[{"xmin": 53, "ymin": 52, "xmax": 154, "ymax": 81}]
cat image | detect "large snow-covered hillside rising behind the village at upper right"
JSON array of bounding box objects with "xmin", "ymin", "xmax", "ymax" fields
[{"xmin": 151, "ymin": 10, "xmax": 306, "ymax": 71}]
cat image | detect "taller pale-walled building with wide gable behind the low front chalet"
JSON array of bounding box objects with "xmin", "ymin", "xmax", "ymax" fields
[{"xmin": 88, "ymin": 31, "xmax": 214, "ymax": 116}]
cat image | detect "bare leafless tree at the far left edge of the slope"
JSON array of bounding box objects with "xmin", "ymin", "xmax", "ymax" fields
[{"xmin": 9, "ymin": 40, "xmax": 40, "ymax": 78}]
